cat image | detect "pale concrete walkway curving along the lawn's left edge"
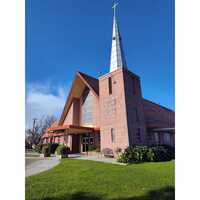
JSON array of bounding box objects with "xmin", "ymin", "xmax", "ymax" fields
[{"xmin": 26, "ymin": 157, "xmax": 60, "ymax": 177}]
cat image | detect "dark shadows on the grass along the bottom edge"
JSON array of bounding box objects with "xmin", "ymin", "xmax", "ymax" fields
[{"xmin": 34, "ymin": 187, "xmax": 175, "ymax": 200}]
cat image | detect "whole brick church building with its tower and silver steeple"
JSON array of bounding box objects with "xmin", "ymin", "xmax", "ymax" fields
[{"xmin": 43, "ymin": 5, "xmax": 175, "ymax": 155}]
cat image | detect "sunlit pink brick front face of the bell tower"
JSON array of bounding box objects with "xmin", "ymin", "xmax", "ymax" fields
[{"xmin": 99, "ymin": 70, "xmax": 129, "ymax": 150}]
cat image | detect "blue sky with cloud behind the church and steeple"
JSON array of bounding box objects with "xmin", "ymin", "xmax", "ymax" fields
[{"xmin": 26, "ymin": 0, "xmax": 175, "ymax": 127}]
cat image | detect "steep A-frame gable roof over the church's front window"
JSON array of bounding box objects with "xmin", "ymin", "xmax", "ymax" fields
[{"xmin": 59, "ymin": 72, "xmax": 99, "ymax": 125}]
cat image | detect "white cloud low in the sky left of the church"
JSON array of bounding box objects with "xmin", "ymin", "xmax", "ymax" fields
[{"xmin": 26, "ymin": 83, "xmax": 69, "ymax": 128}]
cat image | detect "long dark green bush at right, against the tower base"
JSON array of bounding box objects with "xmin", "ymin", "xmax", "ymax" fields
[{"xmin": 117, "ymin": 145, "xmax": 175, "ymax": 163}]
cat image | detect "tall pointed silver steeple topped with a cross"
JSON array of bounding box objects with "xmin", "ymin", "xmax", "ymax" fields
[{"xmin": 110, "ymin": 3, "xmax": 127, "ymax": 72}]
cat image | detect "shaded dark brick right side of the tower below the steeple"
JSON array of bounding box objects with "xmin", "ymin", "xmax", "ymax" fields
[{"xmin": 123, "ymin": 70, "xmax": 147, "ymax": 145}]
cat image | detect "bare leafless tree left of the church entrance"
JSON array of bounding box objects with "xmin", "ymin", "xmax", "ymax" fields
[{"xmin": 25, "ymin": 115, "xmax": 56, "ymax": 148}]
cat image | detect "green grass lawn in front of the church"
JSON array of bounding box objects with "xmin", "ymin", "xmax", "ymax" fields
[{"xmin": 26, "ymin": 159, "xmax": 174, "ymax": 200}]
